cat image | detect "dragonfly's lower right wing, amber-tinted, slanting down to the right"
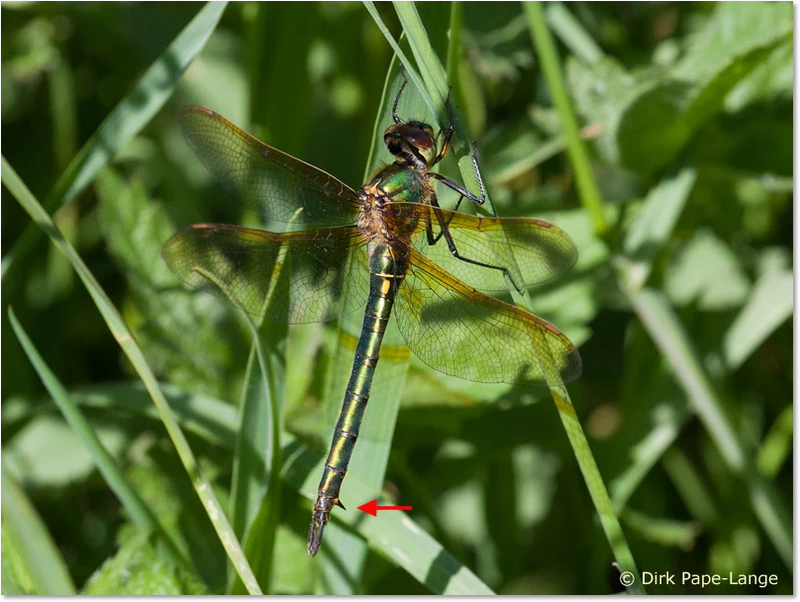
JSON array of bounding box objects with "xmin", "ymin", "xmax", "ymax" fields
[{"xmin": 394, "ymin": 249, "xmax": 581, "ymax": 385}]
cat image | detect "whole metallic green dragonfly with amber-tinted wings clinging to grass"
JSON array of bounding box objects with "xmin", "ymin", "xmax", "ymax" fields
[{"xmin": 162, "ymin": 74, "xmax": 581, "ymax": 556}]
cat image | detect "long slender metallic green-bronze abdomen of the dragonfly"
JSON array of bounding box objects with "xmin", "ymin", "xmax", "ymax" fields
[{"xmin": 308, "ymin": 243, "xmax": 406, "ymax": 556}]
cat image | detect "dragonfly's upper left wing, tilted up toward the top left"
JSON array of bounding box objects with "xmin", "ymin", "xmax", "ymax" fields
[{"xmin": 178, "ymin": 106, "xmax": 358, "ymax": 226}]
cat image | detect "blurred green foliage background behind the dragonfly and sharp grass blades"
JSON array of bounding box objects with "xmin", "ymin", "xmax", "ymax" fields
[{"xmin": 0, "ymin": 2, "xmax": 793, "ymax": 594}]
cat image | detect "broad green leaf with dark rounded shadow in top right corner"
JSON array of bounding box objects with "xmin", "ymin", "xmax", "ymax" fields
[{"xmin": 568, "ymin": 2, "xmax": 791, "ymax": 176}]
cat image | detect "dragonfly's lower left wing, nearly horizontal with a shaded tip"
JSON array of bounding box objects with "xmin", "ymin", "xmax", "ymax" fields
[{"xmin": 162, "ymin": 224, "xmax": 369, "ymax": 324}]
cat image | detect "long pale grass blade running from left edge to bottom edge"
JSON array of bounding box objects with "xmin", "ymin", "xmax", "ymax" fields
[{"xmin": 0, "ymin": 155, "xmax": 261, "ymax": 593}]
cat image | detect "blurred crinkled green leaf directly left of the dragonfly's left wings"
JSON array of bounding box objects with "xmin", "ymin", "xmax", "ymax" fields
[{"xmin": 97, "ymin": 168, "xmax": 245, "ymax": 396}]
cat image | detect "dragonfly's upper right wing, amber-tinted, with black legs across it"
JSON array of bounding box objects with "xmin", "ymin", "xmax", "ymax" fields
[{"xmin": 404, "ymin": 203, "xmax": 578, "ymax": 291}]
